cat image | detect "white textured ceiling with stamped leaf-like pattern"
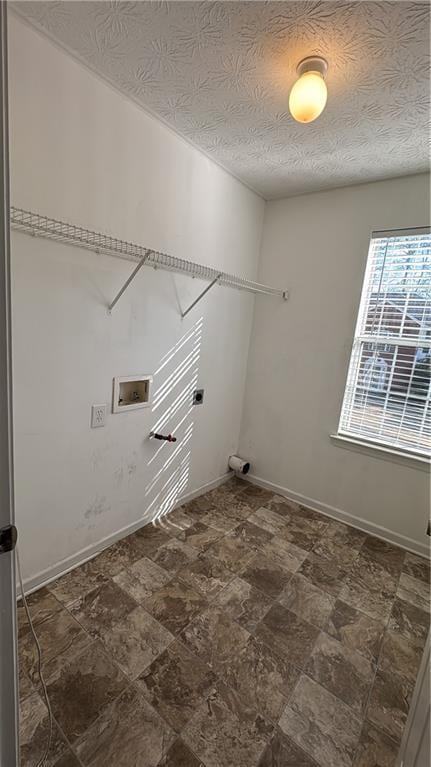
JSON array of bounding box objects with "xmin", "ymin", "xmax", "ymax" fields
[{"xmin": 13, "ymin": 0, "xmax": 430, "ymax": 198}]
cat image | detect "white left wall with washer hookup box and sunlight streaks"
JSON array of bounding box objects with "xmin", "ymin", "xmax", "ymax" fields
[{"xmin": 9, "ymin": 15, "xmax": 264, "ymax": 584}]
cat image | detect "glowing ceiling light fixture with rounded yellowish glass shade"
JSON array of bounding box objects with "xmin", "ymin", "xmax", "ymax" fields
[{"xmin": 289, "ymin": 56, "xmax": 328, "ymax": 123}]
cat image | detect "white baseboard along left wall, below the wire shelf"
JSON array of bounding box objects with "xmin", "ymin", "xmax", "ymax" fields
[{"xmin": 21, "ymin": 472, "xmax": 233, "ymax": 595}]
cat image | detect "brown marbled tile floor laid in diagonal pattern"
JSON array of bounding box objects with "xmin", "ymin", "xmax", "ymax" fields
[{"xmin": 18, "ymin": 480, "xmax": 430, "ymax": 767}]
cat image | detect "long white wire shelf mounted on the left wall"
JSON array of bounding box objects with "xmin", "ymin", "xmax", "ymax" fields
[{"xmin": 10, "ymin": 207, "xmax": 288, "ymax": 308}]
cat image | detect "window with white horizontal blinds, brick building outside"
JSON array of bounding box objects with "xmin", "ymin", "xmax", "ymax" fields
[{"xmin": 338, "ymin": 229, "xmax": 431, "ymax": 457}]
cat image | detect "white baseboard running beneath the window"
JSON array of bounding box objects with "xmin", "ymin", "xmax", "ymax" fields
[{"xmin": 247, "ymin": 474, "xmax": 430, "ymax": 559}]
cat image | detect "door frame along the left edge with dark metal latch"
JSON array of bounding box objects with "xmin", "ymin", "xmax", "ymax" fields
[{"xmin": 0, "ymin": 2, "xmax": 19, "ymax": 767}]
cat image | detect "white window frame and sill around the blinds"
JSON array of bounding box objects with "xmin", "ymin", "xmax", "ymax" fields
[{"xmin": 338, "ymin": 226, "xmax": 431, "ymax": 466}]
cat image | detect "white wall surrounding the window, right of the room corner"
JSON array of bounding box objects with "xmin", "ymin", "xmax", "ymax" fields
[{"xmin": 240, "ymin": 175, "xmax": 430, "ymax": 552}]
